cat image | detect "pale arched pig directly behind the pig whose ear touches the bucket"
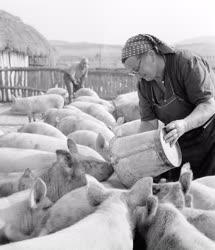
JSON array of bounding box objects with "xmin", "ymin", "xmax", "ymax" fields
[{"xmin": 58, "ymin": 115, "xmax": 114, "ymax": 142}]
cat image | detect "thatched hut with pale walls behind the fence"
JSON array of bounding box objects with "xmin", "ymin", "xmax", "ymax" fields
[{"xmin": 0, "ymin": 10, "xmax": 54, "ymax": 68}]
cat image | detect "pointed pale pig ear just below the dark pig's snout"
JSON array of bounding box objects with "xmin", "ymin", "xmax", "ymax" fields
[{"xmin": 86, "ymin": 174, "xmax": 109, "ymax": 206}]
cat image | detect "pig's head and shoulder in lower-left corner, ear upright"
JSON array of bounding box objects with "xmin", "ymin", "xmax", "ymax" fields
[{"xmin": 0, "ymin": 178, "xmax": 52, "ymax": 243}]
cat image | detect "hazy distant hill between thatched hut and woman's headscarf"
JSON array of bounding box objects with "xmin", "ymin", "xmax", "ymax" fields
[{"xmin": 49, "ymin": 40, "xmax": 123, "ymax": 68}]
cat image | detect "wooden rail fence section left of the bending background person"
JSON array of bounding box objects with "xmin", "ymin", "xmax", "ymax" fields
[{"xmin": 0, "ymin": 67, "xmax": 73, "ymax": 102}]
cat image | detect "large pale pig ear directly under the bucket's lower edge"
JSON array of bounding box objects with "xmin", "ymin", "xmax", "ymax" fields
[{"xmin": 127, "ymin": 177, "xmax": 153, "ymax": 207}]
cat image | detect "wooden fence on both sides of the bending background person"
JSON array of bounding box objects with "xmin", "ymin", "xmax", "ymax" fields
[{"xmin": 0, "ymin": 67, "xmax": 136, "ymax": 102}]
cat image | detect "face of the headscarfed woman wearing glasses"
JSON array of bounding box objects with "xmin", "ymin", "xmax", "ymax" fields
[{"xmin": 125, "ymin": 51, "xmax": 157, "ymax": 81}]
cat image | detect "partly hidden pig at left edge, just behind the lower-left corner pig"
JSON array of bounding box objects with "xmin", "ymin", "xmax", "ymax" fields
[{"xmin": 0, "ymin": 168, "xmax": 35, "ymax": 197}]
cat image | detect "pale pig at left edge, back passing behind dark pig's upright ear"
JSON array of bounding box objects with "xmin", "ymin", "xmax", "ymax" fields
[{"xmin": 0, "ymin": 132, "xmax": 104, "ymax": 161}]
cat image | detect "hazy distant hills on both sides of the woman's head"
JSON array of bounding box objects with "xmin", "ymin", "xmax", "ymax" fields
[{"xmin": 49, "ymin": 36, "xmax": 215, "ymax": 68}]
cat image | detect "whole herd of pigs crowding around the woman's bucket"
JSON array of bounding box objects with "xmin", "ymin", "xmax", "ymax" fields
[{"xmin": 0, "ymin": 88, "xmax": 215, "ymax": 250}]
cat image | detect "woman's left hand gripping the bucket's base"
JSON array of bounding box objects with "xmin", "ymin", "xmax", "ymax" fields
[{"xmin": 164, "ymin": 119, "xmax": 186, "ymax": 146}]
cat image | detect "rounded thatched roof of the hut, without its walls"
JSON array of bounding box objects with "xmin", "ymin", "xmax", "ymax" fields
[{"xmin": 0, "ymin": 10, "xmax": 52, "ymax": 56}]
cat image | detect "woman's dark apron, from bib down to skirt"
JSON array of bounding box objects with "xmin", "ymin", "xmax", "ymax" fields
[{"xmin": 148, "ymin": 72, "xmax": 215, "ymax": 181}]
